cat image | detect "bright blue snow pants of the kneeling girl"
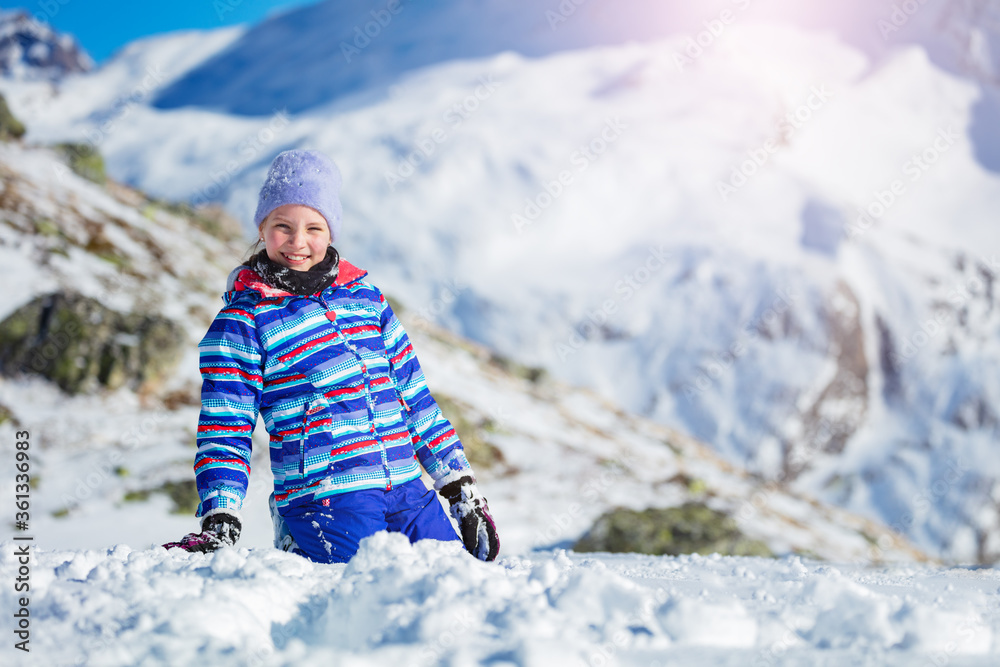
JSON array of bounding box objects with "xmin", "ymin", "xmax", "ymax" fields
[{"xmin": 281, "ymin": 479, "xmax": 461, "ymax": 563}]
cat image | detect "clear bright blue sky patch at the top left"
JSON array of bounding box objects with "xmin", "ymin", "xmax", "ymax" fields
[{"xmin": 23, "ymin": 0, "xmax": 316, "ymax": 63}]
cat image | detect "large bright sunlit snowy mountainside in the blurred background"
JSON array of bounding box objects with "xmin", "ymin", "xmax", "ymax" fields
[{"xmin": 0, "ymin": 3, "xmax": 1000, "ymax": 561}]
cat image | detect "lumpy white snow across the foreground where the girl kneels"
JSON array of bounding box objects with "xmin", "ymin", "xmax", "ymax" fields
[{"xmin": 0, "ymin": 533, "xmax": 1000, "ymax": 667}]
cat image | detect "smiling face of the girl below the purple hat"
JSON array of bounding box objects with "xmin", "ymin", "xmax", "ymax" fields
[{"xmin": 260, "ymin": 204, "xmax": 330, "ymax": 271}]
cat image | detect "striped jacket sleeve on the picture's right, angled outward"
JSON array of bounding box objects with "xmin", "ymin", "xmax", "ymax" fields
[{"xmin": 379, "ymin": 294, "xmax": 472, "ymax": 488}]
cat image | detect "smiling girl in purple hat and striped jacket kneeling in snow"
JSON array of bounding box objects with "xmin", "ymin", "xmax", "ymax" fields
[{"xmin": 164, "ymin": 151, "xmax": 500, "ymax": 563}]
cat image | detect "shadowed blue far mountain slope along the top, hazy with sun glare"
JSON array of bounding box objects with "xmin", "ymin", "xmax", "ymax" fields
[{"xmin": 148, "ymin": 0, "xmax": 1000, "ymax": 115}]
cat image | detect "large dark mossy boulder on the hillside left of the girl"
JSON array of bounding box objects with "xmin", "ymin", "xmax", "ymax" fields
[{"xmin": 0, "ymin": 292, "xmax": 187, "ymax": 394}]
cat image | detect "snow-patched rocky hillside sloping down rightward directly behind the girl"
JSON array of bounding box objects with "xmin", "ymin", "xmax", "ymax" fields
[{"xmin": 0, "ymin": 144, "xmax": 927, "ymax": 562}]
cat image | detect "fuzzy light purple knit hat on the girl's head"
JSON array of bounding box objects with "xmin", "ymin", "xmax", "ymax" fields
[{"xmin": 253, "ymin": 151, "xmax": 342, "ymax": 243}]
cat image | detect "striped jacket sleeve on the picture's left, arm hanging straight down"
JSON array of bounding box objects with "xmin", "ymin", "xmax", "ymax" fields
[{"xmin": 194, "ymin": 304, "xmax": 263, "ymax": 517}]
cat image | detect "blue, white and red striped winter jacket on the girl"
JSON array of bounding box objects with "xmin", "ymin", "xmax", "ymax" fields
[{"xmin": 200, "ymin": 260, "xmax": 469, "ymax": 517}]
